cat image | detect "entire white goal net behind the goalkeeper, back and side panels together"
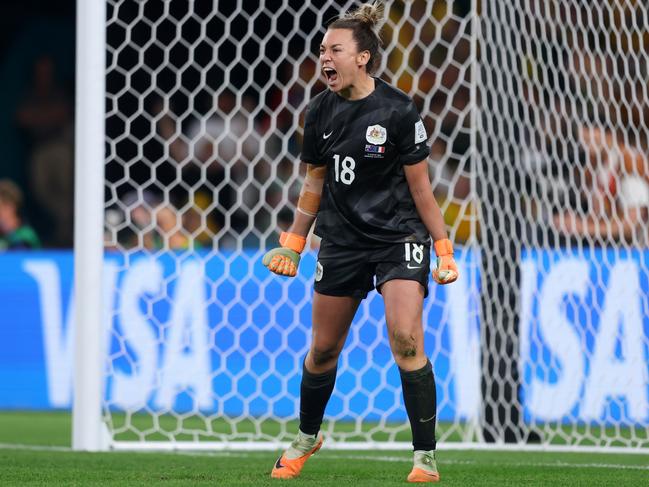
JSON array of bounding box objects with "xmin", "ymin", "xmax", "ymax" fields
[{"xmin": 77, "ymin": 0, "xmax": 649, "ymax": 450}]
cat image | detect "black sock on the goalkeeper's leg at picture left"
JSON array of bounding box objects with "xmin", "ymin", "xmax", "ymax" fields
[{"xmin": 300, "ymin": 365, "xmax": 337, "ymax": 435}]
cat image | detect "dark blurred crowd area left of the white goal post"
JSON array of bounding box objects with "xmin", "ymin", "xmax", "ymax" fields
[{"xmin": 0, "ymin": 0, "xmax": 75, "ymax": 249}]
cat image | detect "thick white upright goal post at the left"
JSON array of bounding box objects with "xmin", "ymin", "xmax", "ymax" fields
[{"xmin": 72, "ymin": 0, "xmax": 107, "ymax": 451}]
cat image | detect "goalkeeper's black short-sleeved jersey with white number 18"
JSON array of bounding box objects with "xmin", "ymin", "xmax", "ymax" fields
[{"xmin": 301, "ymin": 78, "xmax": 430, "ymax": 247}]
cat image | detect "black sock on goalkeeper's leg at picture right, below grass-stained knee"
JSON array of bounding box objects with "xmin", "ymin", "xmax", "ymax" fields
[{"xmin": 399, "ymin": 360, "xmax": 437, "ymax": 450}]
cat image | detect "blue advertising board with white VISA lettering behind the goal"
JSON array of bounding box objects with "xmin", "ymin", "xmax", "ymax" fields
[{"xmin": 0, "ymin": 250, "xmax": 649, "ymax": 424}]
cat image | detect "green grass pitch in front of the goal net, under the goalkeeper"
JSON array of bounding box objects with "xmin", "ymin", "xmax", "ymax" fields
[{"xmin": 0, "ymin": 412, "xmax": 649, "ymax": 487}]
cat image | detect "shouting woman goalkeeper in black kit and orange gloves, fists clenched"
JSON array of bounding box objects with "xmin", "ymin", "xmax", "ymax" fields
[{"xmin": 263, "ymin": 2, "xmax": 458, "ymax": 482}]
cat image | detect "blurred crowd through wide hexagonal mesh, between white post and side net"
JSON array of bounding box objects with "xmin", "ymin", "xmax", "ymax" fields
[{"xmin": 102, "ymin": 0, "xmax": 470, "ymax": 252}]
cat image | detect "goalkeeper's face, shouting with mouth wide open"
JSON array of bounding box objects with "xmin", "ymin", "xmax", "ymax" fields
[{"xmin": 320, "ymin": 29, "xmax": 369, "ymax": 92}]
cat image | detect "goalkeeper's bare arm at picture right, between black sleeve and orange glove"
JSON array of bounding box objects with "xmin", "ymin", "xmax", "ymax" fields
[{"xmin": 403, "ymin": 160, "xmax": 448, "ymax": 241}]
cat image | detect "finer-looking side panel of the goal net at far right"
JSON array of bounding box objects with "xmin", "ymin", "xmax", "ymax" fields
[{"xmin": 475, "ymin": 0, "xmax": 649, "ymax": 448}]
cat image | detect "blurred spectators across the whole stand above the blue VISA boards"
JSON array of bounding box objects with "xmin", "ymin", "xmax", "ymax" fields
[{"xmin": 0, "ymin": 0, "xmax": 649, "ymax": 249}]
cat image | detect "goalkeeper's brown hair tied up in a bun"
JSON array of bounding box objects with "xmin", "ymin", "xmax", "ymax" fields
[{"xmin": 328, "ymin": 0, "xmax": 384, "ymax": 74}]
